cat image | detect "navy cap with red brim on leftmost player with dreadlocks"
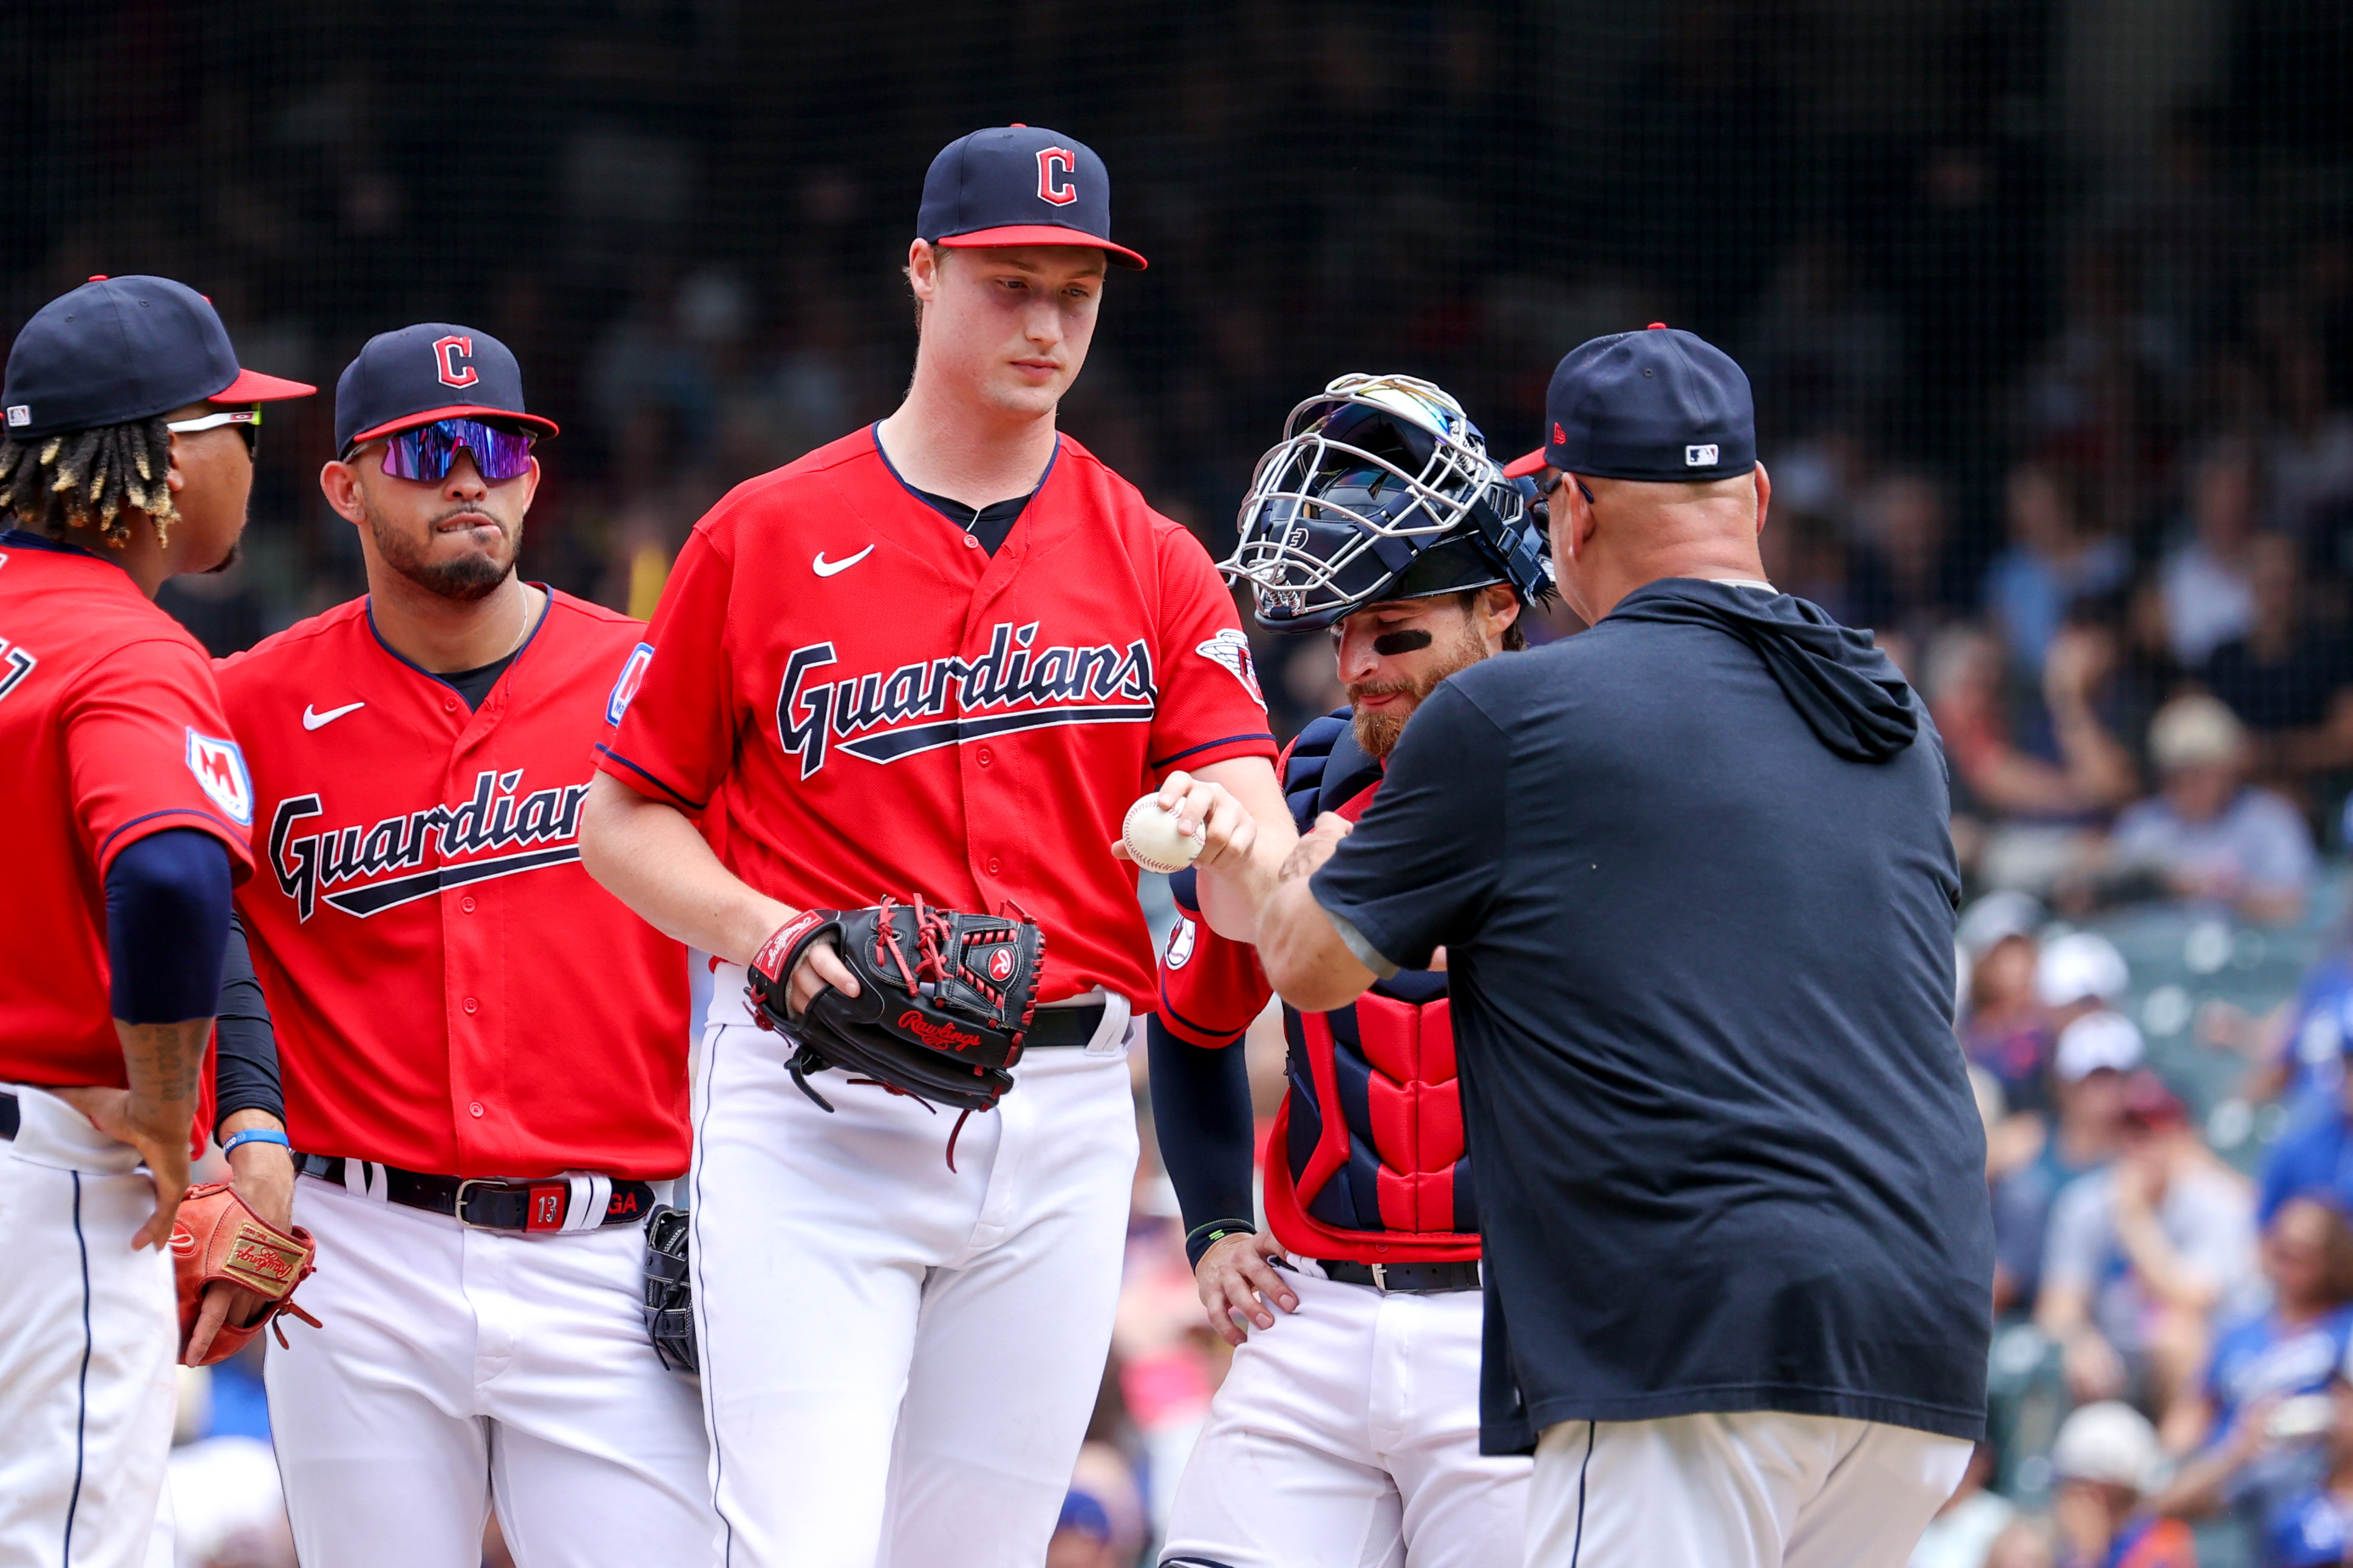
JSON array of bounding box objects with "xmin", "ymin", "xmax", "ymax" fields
[{"xmin": 0, "ymin": 277, "xmax": 318, "ymax": 440}]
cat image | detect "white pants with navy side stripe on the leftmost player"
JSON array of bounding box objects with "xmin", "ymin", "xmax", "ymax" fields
[{"xmin": 0, "ymin": 1084, "xmax": 179, "ymax": 1568}]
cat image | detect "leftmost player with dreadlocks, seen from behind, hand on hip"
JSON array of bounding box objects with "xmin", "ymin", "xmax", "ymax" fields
[{"xmin": 0, "ymin": 277, "xmax": 313, "ymax": 1568}]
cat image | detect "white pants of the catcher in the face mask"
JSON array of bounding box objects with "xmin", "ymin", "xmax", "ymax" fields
[{"xmin": 1160, "ymin": 1264, "xmax": 1530, "ymax": 1568}]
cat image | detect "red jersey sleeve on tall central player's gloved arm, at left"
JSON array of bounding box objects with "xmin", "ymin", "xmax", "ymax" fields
[{"xmin": 598, "ymin": 529, "xmax": 739, "ymax": 816}]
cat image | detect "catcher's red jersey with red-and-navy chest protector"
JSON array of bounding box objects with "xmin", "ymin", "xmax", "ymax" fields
[{"xmin": 1158, "ymin": 708, "xmax": 1480, "ymax": 1263}]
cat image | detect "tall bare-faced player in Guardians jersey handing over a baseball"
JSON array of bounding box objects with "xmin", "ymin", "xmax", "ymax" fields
[{"xmin": 581, "ymin": 124, "xmax": 1294, "ymax": 1568}]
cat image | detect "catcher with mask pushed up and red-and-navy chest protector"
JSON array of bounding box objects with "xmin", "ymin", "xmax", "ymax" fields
[{"xmin": 1148, "ymin": 376, "xmax": 1551, "ymax": 1568}]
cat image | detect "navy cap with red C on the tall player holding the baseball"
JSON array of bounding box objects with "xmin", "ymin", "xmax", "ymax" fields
[{"xmin": 915, "ymin": 124, "xmax": 1146, "ymax": 270}]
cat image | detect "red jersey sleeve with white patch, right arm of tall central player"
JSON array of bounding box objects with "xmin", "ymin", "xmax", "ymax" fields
[{"xmin": 1151, "ymin": 524, "xmax": 1275, "ymax": 773}]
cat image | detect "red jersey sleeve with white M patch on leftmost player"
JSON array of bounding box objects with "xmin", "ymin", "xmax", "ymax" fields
[{"xmin": 59, "ymin": 637, "xmax": 254, "ymax": 881}]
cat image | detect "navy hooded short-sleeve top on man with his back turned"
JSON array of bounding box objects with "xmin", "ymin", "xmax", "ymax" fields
[{"xmin": 1310, "ymin": 579, "xmax": 1993, "ymax": 1453}]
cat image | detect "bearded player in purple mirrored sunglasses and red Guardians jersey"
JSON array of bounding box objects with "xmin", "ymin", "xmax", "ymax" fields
[{"xmin": 219, "ymin": 322, "xmax": 715, "ymax": 1568}]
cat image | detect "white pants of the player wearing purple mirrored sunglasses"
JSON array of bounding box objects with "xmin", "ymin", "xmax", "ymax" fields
[{"xmin": 264, "ymin": 1175, "xmax": 718, "ymax": 1568}]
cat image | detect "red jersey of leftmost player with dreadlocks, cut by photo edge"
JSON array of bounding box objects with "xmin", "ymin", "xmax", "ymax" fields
[{"xmin": 0, "ymin": 529, "xmax": 254, "ymax": 1091}]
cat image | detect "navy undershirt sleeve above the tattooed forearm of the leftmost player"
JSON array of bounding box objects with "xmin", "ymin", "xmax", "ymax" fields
[{"xmin": 106, "ymin": 827, "xmax": 228, "ymax": 1023}]
